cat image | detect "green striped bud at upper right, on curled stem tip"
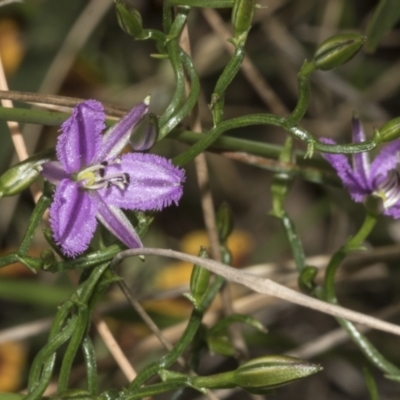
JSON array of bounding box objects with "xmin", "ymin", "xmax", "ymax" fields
[{"xmin": 313, "ymin": 33, "xmax": 366, "ymax": 71}]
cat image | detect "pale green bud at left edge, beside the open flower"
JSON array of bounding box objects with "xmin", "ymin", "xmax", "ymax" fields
[{"xmin": 0, "ymin": 149, "xmax": 54, "ymax": 198}]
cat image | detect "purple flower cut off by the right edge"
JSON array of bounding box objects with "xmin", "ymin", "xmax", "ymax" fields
[{"xmin": 322, "ymin": 118, "xmax": 400, "ymax": 218}]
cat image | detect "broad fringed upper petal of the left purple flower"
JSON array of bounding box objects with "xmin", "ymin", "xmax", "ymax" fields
[{"xmin": 56, "ymin": 100, "xmax": 105, "ymax": 174}]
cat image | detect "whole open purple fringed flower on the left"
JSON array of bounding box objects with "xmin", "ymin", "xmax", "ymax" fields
[{"xmin": 41, "ymin": 100, "xmax": 185, "ymax": 257}]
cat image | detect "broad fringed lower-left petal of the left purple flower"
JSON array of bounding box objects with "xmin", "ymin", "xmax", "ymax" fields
[{"xmin": 50, "ymin": 179, "xmax": 97, "ymax": 257}]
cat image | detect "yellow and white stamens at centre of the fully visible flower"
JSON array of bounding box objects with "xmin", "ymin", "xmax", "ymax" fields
[{"xmin": 76, "ymin": 158, "xmax": 130, "ymax": 190}]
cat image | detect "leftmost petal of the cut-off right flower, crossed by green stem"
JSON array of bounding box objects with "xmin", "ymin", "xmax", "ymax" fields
[{"xmin": 321, "ymin": 138, "xmax": 371, "ymax": 202}]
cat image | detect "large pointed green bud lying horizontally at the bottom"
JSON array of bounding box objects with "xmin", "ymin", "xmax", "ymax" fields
[{"xmin": 233, "ymin": 355, "xmax": 321, "ymax": 393}]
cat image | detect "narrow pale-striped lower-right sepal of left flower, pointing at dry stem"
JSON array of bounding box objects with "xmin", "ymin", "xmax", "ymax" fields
[{"xmin": 93, "ymin": 192, "xmax": 143, "ymax": 249}]
